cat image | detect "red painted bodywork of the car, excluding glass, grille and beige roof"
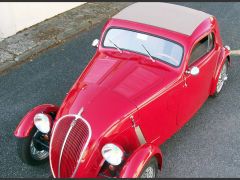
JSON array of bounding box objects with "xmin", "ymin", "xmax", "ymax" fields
[{"xmin": 15, "ymin": 8, "xmax": 229, "ymax": 177}]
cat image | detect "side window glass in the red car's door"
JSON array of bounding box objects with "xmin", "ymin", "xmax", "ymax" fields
[{"xmin": 188, "ymin": 33, "xmax": 214, "ymax": 65}]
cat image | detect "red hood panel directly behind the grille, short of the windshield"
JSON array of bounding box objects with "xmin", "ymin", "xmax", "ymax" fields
[{"xmin": 56, "ymin": 81, "xmax": 136, "ymax": 139}]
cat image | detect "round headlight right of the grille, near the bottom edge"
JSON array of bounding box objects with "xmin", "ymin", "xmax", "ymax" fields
[{"xmin": 102, "ymin": 143, "xmax": 123, "ymax": 166}]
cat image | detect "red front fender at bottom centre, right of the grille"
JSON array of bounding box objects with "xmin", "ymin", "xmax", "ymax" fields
[{"xmin": 119, "ymin": 144, "xmax": 162, "ymax": 178}]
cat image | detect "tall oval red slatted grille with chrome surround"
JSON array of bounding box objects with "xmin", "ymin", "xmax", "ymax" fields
[{"xmin": 50, "ymin": 115, "xmax": 91, "ymax": 178}]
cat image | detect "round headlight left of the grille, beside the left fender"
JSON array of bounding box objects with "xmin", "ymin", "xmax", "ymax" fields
[{"xmin": 33, "ymin": 113, "xmax": 50, "ymax": 133}]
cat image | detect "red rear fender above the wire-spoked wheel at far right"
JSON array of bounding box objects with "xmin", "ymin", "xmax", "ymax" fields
[{"xmin": 210, "ymin": 47, "xmax": 231, "ymax": 95}]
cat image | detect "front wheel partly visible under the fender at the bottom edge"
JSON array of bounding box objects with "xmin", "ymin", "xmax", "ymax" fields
[{"xmin": 140, "ymin": 157, "xmax": 158, "ymax": 178}]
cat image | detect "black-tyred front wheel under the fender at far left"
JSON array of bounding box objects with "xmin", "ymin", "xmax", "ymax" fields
[{"xmin": 17, "ymin": 128, "xmax": 49, "ymax": 165}]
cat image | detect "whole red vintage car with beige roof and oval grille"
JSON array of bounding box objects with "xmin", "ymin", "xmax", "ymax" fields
[{"xmin": 14, "ymin": 2, "xmax": 230, "ymax": 178}]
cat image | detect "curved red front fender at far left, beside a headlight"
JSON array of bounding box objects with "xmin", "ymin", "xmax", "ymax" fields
[{"xmin": 14, "ymin": 104, "xmax": 59, "ymax": 138}]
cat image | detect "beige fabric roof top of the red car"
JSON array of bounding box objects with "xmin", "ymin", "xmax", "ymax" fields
[{"xmin": 113, "ymin": 2, "xmax": 212, "ymax": 36}]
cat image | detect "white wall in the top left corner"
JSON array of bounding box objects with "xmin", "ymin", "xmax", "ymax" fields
[{"xmin": 0, "ymin": 2, "xmax": 84, "ymax": 40}]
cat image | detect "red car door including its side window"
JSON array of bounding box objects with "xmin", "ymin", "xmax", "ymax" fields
[{"xmin": 177, "ymin": 32, "xmax": 218, "ymax": 126}]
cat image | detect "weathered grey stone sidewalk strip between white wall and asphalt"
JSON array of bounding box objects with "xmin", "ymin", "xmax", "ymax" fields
[{"xmin": 0, "ymin": 2, "xmax": 132, "ymax": 73}]
